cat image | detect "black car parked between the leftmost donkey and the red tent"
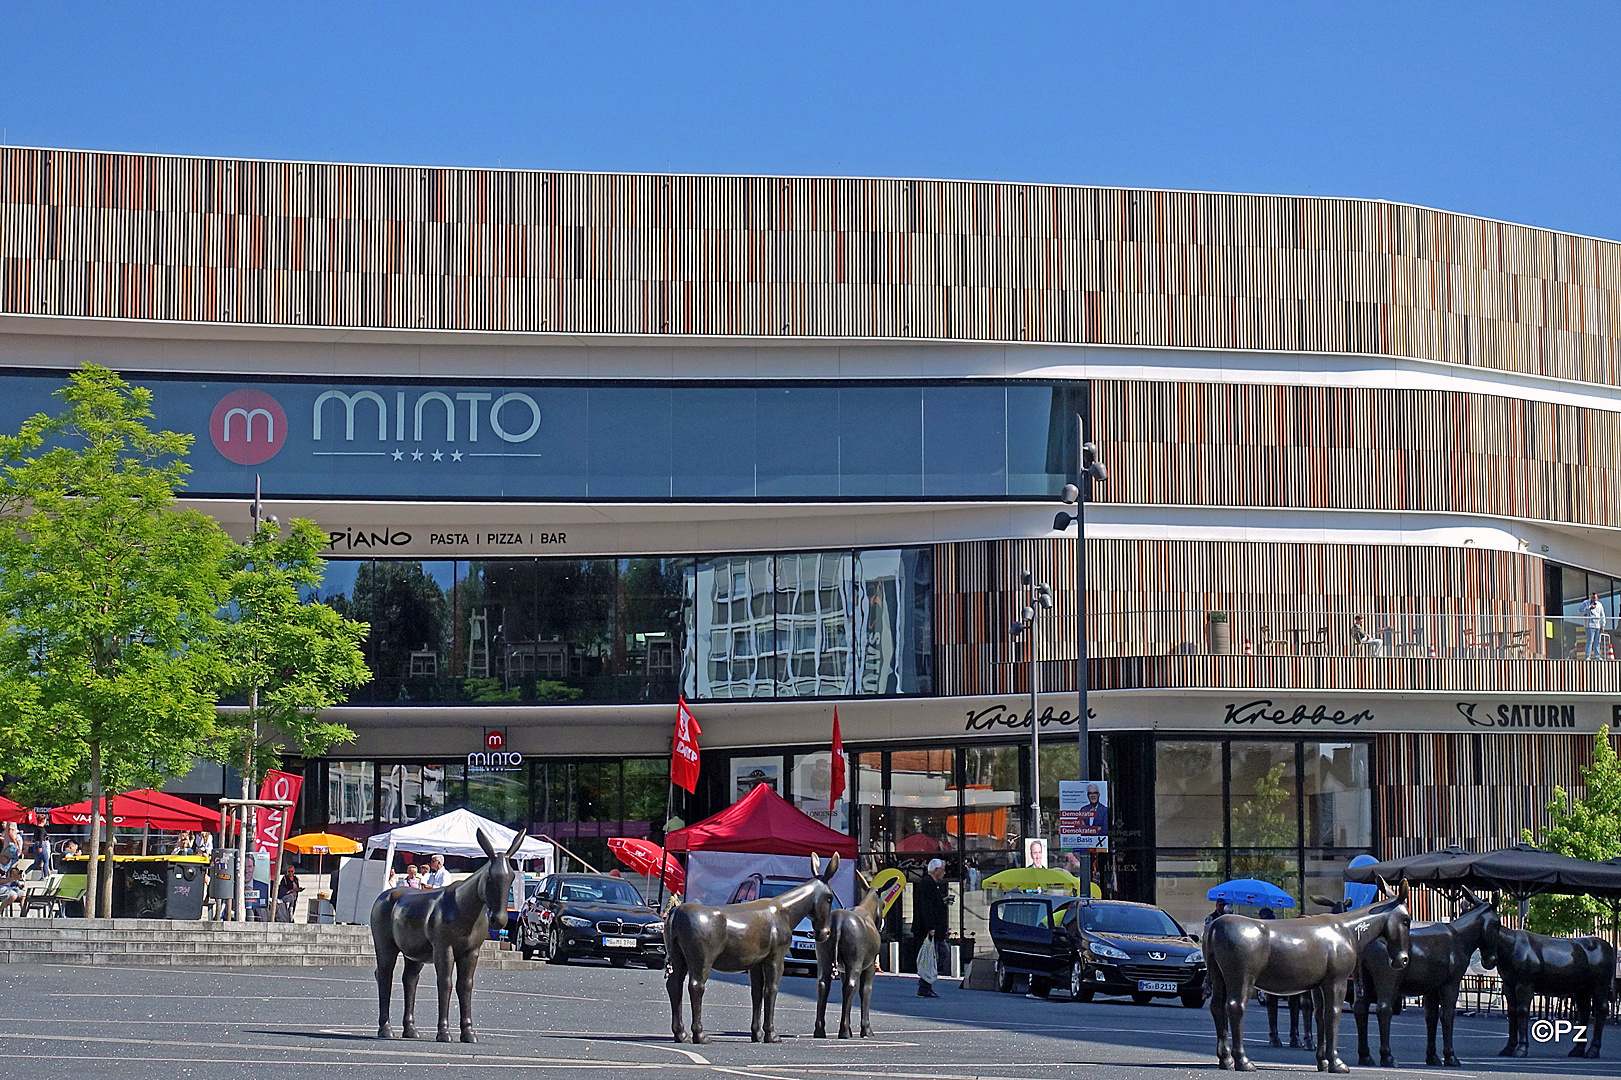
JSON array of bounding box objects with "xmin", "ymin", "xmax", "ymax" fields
[{"xmin": 512, "ymin": 874, "xmax": 665, "ymax": 968}]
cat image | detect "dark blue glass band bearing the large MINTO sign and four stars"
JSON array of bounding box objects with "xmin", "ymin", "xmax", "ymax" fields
[{"xmin": 0, "ymin": 375, "xmax": 1086, "ymax": 499}]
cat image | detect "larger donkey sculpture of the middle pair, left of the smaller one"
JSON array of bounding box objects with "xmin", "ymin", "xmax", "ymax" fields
[{"xmin": 665, "ymin": 853, "xmax": 838, "ymax": 1043}]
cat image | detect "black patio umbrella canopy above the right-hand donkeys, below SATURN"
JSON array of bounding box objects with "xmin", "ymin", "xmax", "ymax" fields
[{"xmin": 1345, "ymin": 843, "xmax": 1621, "ymax": 900}]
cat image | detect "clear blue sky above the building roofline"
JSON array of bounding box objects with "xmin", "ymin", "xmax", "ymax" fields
[{"xmin": 0, "ymin": 0, "xmax": 1621, "ymax": 238}]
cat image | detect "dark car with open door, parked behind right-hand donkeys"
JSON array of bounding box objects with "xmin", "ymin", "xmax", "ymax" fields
[{"xmin": 990, "ymin": 895, "xmax": 1204, "ymax": 1009}]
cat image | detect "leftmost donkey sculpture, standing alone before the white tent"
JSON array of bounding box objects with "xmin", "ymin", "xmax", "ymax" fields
[{"xmin": 371, "ymin": 829, "xmax": 524, "ymax": 1043}]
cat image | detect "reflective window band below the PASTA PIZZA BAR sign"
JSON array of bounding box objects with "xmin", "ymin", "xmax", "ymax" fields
[{"xmin": 316, "ymin": 548, "xmax": 934, "ymax": 704}]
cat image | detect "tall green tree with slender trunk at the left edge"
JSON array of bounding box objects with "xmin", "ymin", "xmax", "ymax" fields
[{"xmin": 0, "ymin": 366, "xmax": 230, "ymax": 911}]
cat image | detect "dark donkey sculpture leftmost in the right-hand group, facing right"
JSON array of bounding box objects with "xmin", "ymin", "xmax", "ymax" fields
[{"xmin": 1204, "ymin": 885, "xmax": 1410, "ymax": 1072}]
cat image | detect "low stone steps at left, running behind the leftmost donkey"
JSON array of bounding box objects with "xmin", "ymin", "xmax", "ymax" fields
[{"xmin": 0, "ymin": 918, "xmax": 540, "ymax": 971}]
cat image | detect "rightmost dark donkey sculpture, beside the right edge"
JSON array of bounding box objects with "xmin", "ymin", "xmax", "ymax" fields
[{"xmin": 1498, "ymin": 926, "xmax": 1616, "ymax": 1057}]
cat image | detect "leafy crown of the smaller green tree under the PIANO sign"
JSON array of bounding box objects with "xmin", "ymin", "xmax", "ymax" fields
[{"xmin": 216, "ymin": 519, "xmax": 371, "ymax": 781}]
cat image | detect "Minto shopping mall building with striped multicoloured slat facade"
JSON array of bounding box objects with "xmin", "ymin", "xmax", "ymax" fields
[{"xmin": 0, "ymin": 149, "xmax": 1621, "ymax": 921}]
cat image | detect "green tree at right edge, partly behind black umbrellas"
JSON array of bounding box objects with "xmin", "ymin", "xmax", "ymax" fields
[{"xmin": 1524, "ymin": 726, "xmax": 1621, "ymax": 934}]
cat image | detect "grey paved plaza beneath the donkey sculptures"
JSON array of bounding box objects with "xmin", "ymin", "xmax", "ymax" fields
[{"xmin": 0, "ymin": 965, "xmax": 1618, "ymax": 1080}]
